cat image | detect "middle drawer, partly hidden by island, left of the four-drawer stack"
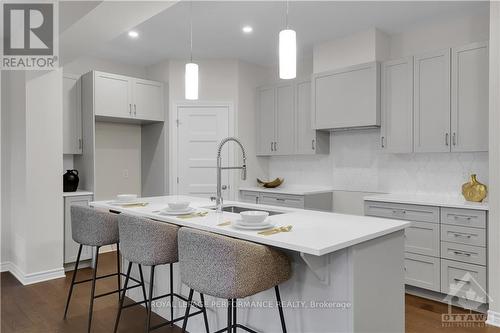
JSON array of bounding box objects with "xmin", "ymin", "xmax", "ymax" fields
[{"xmin": 405, "ymin": 222, "xmax": 439, "ymax": 257}]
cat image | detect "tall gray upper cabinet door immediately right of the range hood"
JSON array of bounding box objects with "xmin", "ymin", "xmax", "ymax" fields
[{"xmin": 380, "ymin": 57, "xmax": 413, "ymax": 153}]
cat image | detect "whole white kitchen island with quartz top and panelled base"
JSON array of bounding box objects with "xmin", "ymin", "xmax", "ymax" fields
[{"xmin": 91, "ymin": 196, "xmax": 410, "ymax": 333}]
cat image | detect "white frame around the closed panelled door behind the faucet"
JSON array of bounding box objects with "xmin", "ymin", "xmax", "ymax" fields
[{"xmin": 168, "ymin": 101, "xmax": 239, "ymax": 200}]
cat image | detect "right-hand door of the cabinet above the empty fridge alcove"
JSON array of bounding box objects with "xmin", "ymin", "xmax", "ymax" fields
[{"xmin": 132, "ymin": 79, "xmax": 165, "ymax": 121}]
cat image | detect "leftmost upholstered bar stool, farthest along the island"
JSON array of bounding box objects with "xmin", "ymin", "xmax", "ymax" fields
[{"xmin": 64, "ymin": 205, "xmax": 146, "ymax": 332}]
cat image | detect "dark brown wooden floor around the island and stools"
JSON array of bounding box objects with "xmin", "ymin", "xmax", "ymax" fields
[{"xmin": 1, "ymin": 253, "xmax": 500, "ymax": 333}]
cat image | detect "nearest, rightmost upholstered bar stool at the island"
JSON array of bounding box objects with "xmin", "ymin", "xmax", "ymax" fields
[{"xmin": 178, "ymin": 228, "xmax": 291, "ymax": 333}]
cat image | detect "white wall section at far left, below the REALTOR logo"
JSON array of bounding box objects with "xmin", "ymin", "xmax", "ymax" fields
[{"xmin": 2, "ymin": 70, "xmax": 64, "ymax": 282}]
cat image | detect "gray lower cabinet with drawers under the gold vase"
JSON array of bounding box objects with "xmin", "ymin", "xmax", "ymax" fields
[{"xmin": 365, "ymin": 201, "xmax": 488, "ymax": 303}]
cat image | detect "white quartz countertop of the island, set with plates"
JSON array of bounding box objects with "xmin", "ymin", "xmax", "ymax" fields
[{"xmin": 90, "ymin": 196, "xmax": 410, "ymax": 256}]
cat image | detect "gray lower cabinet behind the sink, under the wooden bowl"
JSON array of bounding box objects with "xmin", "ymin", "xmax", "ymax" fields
[{"xmin": 240, "ymin": 190, "xmax": 333, "ymax": 211}]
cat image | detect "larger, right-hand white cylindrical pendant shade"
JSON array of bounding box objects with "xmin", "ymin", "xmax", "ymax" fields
[{"xmin": 279, "ymin": 29, "xmax": 297, "ymax": 79}]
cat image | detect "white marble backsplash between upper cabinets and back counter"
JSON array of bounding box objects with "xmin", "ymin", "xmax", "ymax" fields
[{"xmin": 269, "ymin": 129, "xmax": 488, "ymax": 195}]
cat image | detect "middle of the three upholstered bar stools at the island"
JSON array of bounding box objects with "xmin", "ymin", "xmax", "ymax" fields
[{"xmin": 114, "ymin": 214, "xmax": 208, "ymax": 333}]
